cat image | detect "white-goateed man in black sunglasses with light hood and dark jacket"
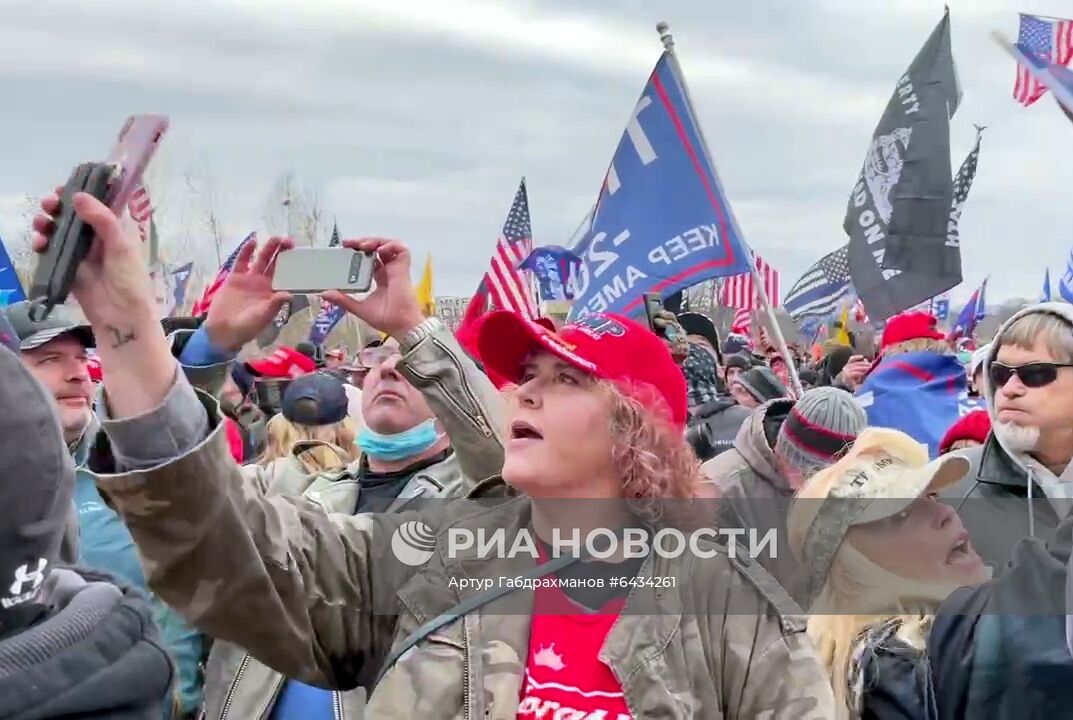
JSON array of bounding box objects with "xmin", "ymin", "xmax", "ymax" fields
[{"xmin": 951, "ymin": 303, "xmax": 1073, "ymax": 571}]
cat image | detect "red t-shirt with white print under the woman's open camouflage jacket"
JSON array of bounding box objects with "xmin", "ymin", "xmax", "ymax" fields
[{"xmin": 517, "ymin": 587, "xmax": 633, "ymax": 720}]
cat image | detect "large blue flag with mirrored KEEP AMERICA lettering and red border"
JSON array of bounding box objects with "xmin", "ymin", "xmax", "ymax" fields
[{"xmin": 571, "ymin": 52, "xmax": 751, "ymax": 319}]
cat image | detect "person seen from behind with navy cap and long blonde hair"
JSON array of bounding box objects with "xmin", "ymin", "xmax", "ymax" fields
[{"xmin": 247, "ymin": 372, "xmax": 358, "ymax": 497}]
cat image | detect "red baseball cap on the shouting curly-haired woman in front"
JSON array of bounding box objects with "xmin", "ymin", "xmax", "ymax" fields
[{"xmin": 477, "ymin": 310, "xmax": 689, "ymax": 428}]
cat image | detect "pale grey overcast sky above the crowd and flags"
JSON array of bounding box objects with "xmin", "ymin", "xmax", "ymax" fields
[{"xmin": 0, "ymin": 0, "xmax": 1073, "ymax": 302}]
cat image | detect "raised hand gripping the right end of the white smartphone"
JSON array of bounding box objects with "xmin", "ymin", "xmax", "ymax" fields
[{"xmin": 321, "ymin": 237, "xmax": 425, "ymax": 339}]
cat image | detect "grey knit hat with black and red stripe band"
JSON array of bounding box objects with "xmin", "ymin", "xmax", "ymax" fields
[{"xmin": 775, "ymin": 387, "xmax": 868, "ymax": 477}]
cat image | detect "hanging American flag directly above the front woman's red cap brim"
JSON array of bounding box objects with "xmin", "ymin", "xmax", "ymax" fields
[{"xmin": 485, "ymin": 178, "xmax": 537, "ymax": 319}]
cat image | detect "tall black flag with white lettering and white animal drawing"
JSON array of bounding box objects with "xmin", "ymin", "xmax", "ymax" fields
[{"xmin": 844, "ymin": 12, "xmax": 961, "ymax": 321}]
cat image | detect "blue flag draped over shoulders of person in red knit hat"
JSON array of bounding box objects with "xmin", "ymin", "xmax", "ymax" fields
[{"xmin": 856, "ymin": 352, "xmax": 984, "ymax": 459}]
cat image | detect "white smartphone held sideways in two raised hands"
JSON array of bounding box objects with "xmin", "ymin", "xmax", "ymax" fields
[{"xmin": 271, "ymin": 248, "xmax": 376, "ymax": 293}]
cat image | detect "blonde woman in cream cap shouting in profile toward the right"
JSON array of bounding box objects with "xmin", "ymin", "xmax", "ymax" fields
[{"xmin": 789, "ymin": 428, "xmax": 989, "ymax": 718}]
